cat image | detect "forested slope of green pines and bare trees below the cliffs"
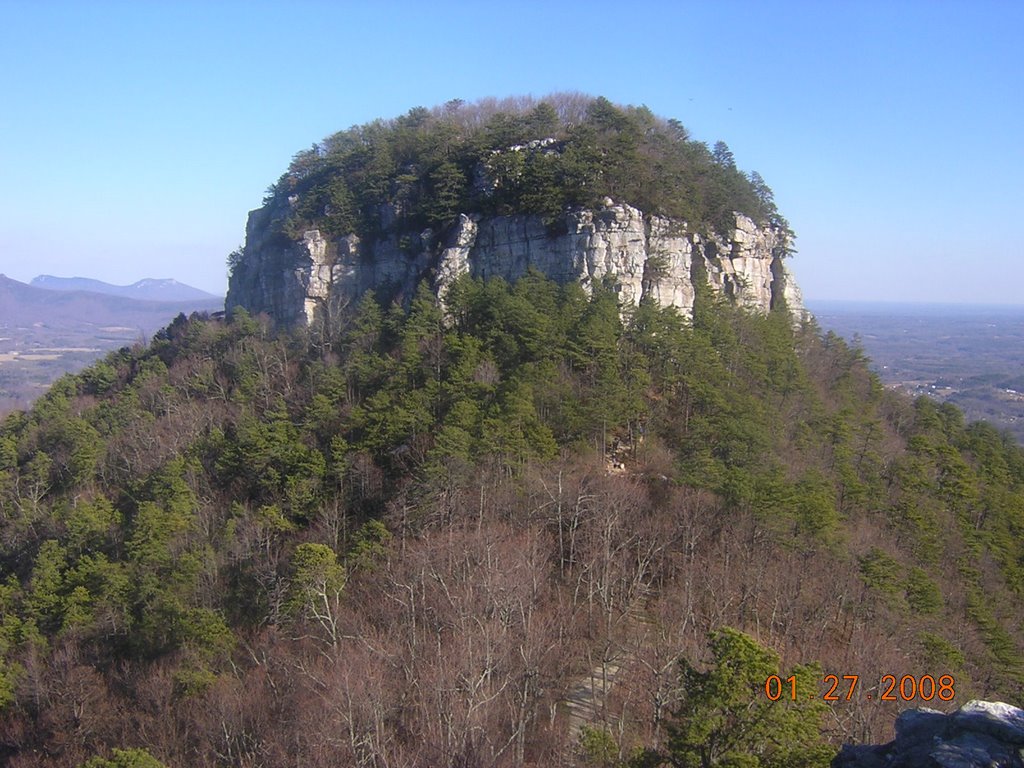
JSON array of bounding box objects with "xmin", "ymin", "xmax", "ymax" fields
[{"xmin": 0, "ymin": 274, "xmax": 1024, "ymax": 768}]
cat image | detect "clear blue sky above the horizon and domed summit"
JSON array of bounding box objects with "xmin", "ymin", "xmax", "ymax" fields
[{"xmin": 0, "ymin": 0, "xmax": 1024, "ymax": 303}]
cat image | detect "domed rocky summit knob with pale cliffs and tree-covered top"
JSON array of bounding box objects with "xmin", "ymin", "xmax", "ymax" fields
[{"xmin": 227, "ymin": 95, "xmax": 803, "ymax": 325}]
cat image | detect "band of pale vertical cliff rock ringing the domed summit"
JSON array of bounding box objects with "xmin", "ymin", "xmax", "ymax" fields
[{"xmin": 226, "ymin": 200, "xmax": 805, "ymax": 325}]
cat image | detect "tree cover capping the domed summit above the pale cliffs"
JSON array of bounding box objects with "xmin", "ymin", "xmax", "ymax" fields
[{"xmin": 243, "ymin": 93, "xmax": 792, "ymax": 253}]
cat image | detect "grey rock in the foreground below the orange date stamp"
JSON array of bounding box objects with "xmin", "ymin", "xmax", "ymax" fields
[{"xmin": 831, "ymin": 701, "xmax": 1024, "ymax": 768}]
